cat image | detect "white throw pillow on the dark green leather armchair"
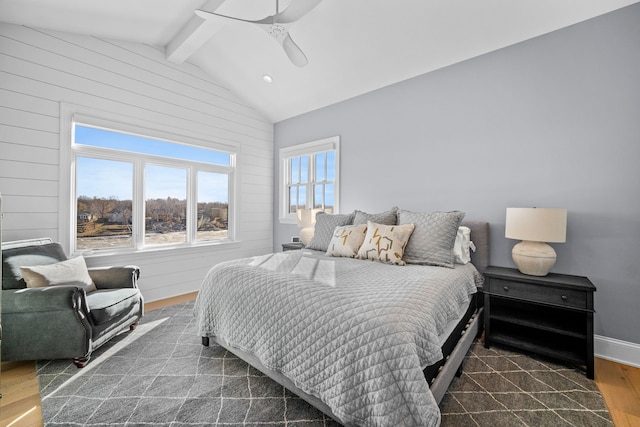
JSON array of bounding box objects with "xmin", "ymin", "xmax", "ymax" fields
[{"xmin": 20, "ymin": 256, "xmax": 96, "ymax": 292}]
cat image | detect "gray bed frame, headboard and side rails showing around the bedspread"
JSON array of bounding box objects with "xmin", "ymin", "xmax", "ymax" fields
[{"xmin": 202, "ymin": 221, "xmax": 489, "ymax": 422}]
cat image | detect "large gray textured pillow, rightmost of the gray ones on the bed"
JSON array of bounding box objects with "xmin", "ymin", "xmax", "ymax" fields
[{"xmin": 398, "ymin": 210, "xmax": 464, "ymax": 268}]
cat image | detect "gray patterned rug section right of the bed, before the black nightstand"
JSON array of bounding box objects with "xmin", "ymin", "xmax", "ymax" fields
[{"xmin": 440, "ymin": 341, "xmax": 613, "ymax": 427}]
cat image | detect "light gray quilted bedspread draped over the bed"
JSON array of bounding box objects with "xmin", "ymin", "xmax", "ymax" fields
[{"xmin": 195, "ymin": 251, "xmax": 482, "ymax": 426}]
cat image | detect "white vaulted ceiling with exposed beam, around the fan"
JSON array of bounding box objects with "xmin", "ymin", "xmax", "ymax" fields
[{"xmin": 0, "ymin": 0, "xmax": 639, "ymax": 122}]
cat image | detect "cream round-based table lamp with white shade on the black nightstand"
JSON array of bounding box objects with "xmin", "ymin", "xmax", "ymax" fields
[{"xmin": 504, "ymin": 208, "xmax": 567, "ymax": 276}]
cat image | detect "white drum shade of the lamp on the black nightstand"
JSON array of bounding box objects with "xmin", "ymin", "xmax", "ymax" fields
[{"xmin": 504, "ymin": 208, "xmax": 567, "ymax": 243}]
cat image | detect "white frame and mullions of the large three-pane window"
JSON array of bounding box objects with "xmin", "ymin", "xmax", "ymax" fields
[{"xmin": 59, "ymin": 103, "xmax": 239, "ymax": 256}]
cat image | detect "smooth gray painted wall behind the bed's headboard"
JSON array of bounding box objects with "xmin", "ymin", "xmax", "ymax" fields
[{"xmin": 274, "ymin": 4, "xmax": 640, "ymax": 343}]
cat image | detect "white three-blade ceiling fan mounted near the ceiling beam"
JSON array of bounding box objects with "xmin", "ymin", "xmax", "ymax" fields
[{"xmin": 195, "ymin": 0, "xmax": 322, "ymax": 67}]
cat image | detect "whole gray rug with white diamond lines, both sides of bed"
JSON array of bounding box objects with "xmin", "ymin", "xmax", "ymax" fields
[{"xmin": 37, "ymin": 302, "xmax": 613, "ymax": 427}]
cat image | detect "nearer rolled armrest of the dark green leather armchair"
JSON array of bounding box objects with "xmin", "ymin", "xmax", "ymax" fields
[{"xmin": 2, "ymin": 285, "xmax": 87, "ymax": 315}]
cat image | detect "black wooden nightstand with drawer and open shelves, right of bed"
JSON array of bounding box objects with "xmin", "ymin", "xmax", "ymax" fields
[{"xmin": 484, "ymin": 266, "xmax": 596, "ymax": 379}]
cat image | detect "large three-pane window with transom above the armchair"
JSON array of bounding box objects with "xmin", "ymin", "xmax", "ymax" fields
[{"xmin": 70, "ymin": 119, "xmax": 235, "ymax": 252}]
